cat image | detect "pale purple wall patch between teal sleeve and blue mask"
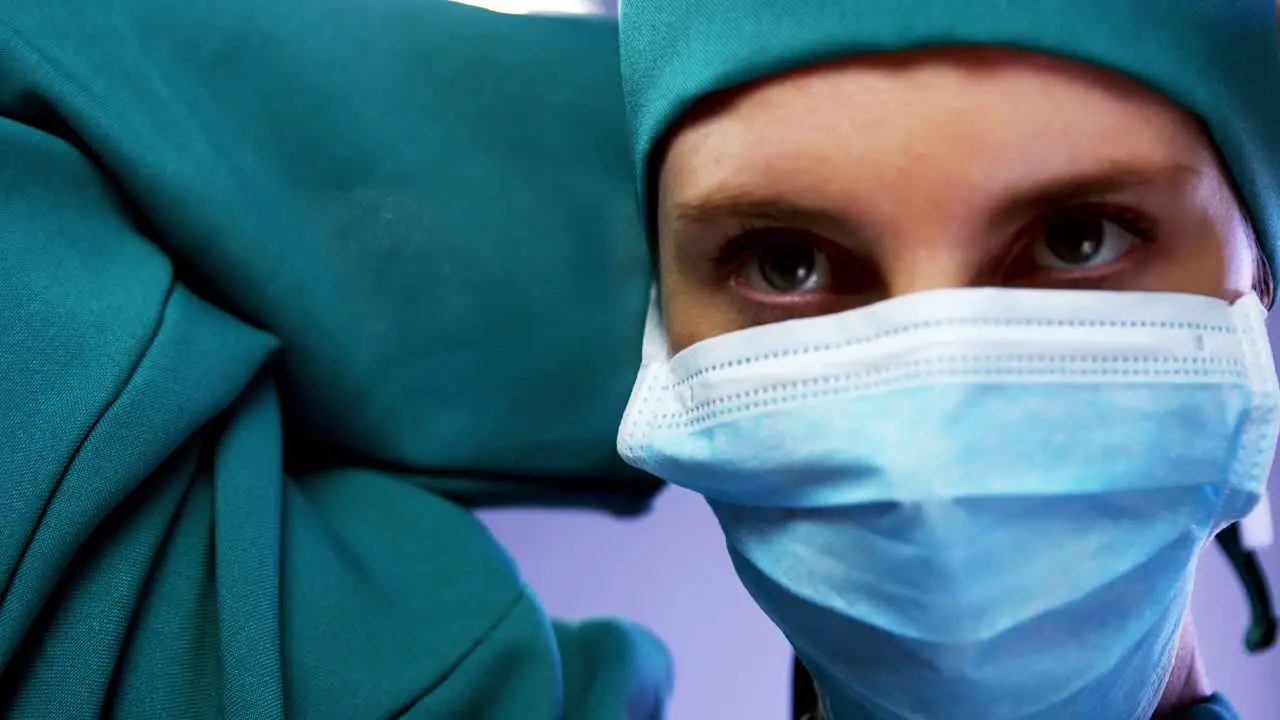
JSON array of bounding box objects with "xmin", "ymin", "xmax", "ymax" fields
[{"xmin": 481, "ymin": 488, "xmax": 791, "ymax": 720}]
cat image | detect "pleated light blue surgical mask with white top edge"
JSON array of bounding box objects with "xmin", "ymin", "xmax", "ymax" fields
[{"xmin": 618, "ymin": 288, "xmax": 1280, "ymax": 720}]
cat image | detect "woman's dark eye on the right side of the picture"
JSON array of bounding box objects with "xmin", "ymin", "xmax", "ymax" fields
[{"xmin": 1030, "ymin": 209, "xmax": 1143, "ymax": 270}]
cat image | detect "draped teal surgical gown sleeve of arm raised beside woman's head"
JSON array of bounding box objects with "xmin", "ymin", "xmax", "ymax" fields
[{"xmin": 0, "ymin": 0, "xmax": 671, "ymax": 720}]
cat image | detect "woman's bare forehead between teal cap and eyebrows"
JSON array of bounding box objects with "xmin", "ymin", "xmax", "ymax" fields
[{"xmin": 659, "ymin": 49, "xmax": 1216, "ymax": 204}]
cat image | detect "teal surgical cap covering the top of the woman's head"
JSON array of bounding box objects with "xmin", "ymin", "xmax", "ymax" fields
[{"xmin": 621, "ymin": 0, "xmax": 1280, "ymax": 281}]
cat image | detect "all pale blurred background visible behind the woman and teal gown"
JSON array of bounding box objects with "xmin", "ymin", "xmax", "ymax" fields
[{"xmin": 456, "ymin": 0, "xmax": 1280, "ymax": 720}]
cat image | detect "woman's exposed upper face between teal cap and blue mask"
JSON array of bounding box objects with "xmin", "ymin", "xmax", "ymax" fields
[{"xmin": 658, "ymin": 49, "xmax": 1254, "ymax": 351}]
